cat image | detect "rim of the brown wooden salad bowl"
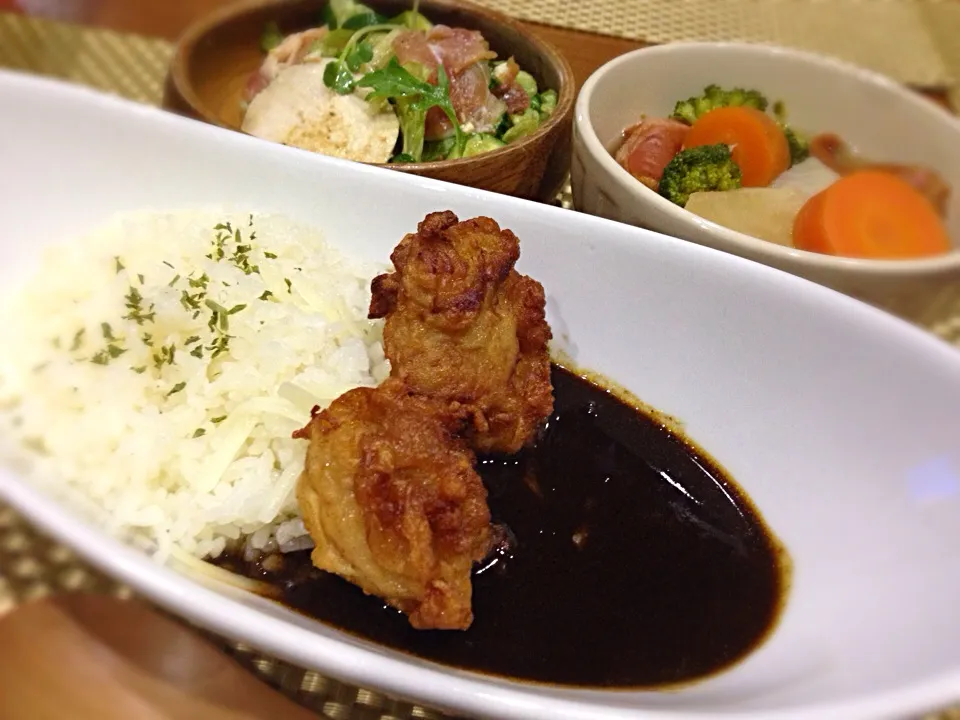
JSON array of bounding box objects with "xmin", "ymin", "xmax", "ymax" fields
[{"xmin": 168, "ymin": 0, "xmax": 576, "ymax": 173}]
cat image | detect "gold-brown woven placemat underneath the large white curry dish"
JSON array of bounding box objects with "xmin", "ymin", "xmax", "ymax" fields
[{"xmin": 0, "ymin": 11, "xmax": 960, "ymax": 720}]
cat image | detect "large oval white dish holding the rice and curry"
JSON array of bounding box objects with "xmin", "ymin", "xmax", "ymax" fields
[{"xmin": 0, "ymin": 73, "xmax": 960, "ymax": 720}]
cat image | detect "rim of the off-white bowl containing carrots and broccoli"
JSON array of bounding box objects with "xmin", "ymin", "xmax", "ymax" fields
[{"xmin": 574, "ymin": 42, "xmax": 960, "ymax": 277}]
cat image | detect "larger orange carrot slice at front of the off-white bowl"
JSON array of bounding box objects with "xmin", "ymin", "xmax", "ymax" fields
[{"xmin": 793, "ymin": 170, "xmax": 951, "ymax": 259}]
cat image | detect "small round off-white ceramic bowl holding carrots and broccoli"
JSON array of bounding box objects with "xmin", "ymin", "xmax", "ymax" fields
[{"xmin": 572, "ymin": 43, "xmax": 960, "ymax": 307}]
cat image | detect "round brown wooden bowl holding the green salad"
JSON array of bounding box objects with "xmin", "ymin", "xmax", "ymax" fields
[{"xmin": 163, "ymin": 0, "xmax": 575, "ymax": 202}]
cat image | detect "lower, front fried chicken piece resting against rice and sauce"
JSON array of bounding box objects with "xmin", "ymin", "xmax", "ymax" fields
[{"xmin": 295, "ymin": 379, "xmax": 491, "ymax": 629}]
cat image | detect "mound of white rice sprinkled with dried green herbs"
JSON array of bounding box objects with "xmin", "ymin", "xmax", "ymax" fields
[{"xmin": 0, "ymin": 212, "xmax": 389, "ymax": 558}]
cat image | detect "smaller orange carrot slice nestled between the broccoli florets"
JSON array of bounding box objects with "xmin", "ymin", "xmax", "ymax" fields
[{"xmin": 684, "ymin": 107, "xmax": 790, "ymax": 187}]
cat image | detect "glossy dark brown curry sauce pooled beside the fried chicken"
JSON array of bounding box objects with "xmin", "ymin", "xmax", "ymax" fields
[{"xmin": 218, "ymin": 366, "xmax": 786, "ymax": 688}]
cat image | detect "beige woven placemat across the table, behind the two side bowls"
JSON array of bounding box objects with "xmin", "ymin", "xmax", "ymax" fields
[{"xmin": 478, "ymin": 0, "xmax": 960, "ymax": 88}]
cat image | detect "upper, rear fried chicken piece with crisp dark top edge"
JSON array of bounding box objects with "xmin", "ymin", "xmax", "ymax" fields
[{"xmin": 369, "ymin": 211, "xmax": 553, "ymax": 453}]
